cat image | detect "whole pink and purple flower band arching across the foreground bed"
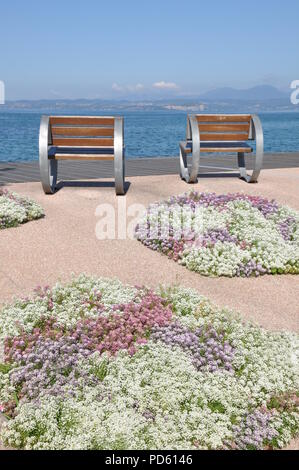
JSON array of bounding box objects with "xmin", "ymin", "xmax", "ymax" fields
[{"xmin": 2, "ymin": 288, "xmax": 238, "ymax": 416}]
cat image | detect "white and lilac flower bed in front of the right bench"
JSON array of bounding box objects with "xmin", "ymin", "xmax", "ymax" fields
[{"xmin": 136, "ymin": 192, "xmax": 299, "ymax": 277}]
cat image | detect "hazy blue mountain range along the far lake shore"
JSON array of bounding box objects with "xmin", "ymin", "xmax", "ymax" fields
[{"xmin": 0, "ymin": 85, "xmax": 299, "ymax": 113}]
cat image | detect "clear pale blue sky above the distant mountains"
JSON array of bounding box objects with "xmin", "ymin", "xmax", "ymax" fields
[{"xmin": 0, "ymin": 0, "xmax": 299, "ymax": 99}]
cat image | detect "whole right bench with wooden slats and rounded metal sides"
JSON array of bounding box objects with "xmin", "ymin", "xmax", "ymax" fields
[{"xmin": 180, "ymin": 114, "xmax": 264, "ymax": 183}]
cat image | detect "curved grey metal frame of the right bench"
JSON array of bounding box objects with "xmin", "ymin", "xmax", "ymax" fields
[{"xmin": 180, "ymin": 114, "xmax": 264, "ymax": 183}]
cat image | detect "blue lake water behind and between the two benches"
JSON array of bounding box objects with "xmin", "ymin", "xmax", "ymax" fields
[{"xmin": 0, "ymin": 108, "xmax": 299, "ymax": 162}]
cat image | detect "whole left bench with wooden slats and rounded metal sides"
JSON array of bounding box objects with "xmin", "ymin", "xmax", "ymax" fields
[{"xmin": 39, "ymin": 116, "xmax": 125, "ymax": 195}]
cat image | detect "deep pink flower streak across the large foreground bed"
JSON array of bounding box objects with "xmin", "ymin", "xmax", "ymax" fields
[{"xmin": 4, "ymin": 291, "xmax": 172, "ymax": 365}]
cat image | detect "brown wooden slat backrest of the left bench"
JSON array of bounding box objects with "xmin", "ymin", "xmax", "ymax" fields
[{"xmin": 50, "ymin": 116, "xmax": 114, "ymax": 147}]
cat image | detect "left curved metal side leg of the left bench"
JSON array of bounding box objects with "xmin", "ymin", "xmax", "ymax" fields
[{"xmin": 39, "ymin": 116, "xmax": 57, "ymax": 194}]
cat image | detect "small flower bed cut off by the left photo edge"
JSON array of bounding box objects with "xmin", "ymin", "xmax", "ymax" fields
[{"xmin": 0, "ymin": 189, "xmax": 44, "ymax": 230}]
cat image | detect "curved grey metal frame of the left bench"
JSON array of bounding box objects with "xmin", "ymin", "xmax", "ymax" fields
[{"xmin": 39, "ymin": 116, "xmax": 125, "ymax": 195}]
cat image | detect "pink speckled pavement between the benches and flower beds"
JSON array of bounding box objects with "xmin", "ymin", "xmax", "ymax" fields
[{"xmin": 0, "ymin": 168, "xmax": 299, "ymax": 448}]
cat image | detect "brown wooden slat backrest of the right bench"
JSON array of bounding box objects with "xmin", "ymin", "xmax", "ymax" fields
[{"xmin": 196, "ymin": 114, "xmax": 251, "ymax": 142}]
